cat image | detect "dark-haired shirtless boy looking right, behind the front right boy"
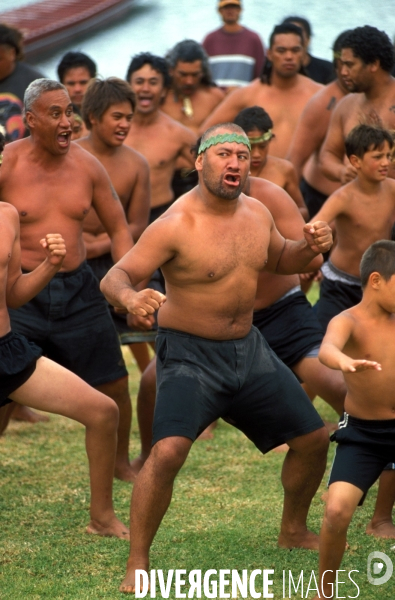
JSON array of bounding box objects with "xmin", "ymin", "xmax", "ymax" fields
[{"xmin": 316, "ymin": 124, "xmax": 395, "ymax": 537}]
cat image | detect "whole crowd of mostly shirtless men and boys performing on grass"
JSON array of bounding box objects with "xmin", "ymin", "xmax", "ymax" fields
[{"xmin": 0, "ymin": 0, "xmax": 395, "ymax": 598}]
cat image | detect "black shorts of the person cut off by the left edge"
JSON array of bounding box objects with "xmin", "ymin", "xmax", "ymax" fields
[{"xmin": 0, "ymin": 331, "xmax": 42, "ymax": 407}]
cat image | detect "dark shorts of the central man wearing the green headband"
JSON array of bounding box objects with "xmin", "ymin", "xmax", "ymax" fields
[{"xmin": 152, "ymin": 327, "xmax": 323, "ymax": 453}]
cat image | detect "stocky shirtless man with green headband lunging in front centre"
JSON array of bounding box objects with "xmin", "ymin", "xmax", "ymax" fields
[{"xmin": 101, "ymin": 123, "xmax": 332, "ymax": 593}]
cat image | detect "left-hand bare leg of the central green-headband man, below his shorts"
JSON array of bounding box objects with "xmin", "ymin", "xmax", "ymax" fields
[{"xmin": 120, "ymin": 437, "xmax": 192, "ymax": 594}]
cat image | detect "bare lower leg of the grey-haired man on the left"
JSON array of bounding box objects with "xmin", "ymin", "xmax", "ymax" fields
[{"xmin": 96, "ymin": 377, "xmax": 138, "ymax": 481}]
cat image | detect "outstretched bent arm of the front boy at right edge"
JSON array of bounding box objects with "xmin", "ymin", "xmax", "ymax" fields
[{"xmin": 318, "ymin": 312, "xmax": 381, "ymax": 373}]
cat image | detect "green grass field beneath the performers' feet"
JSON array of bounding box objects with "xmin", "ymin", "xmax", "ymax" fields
[{"xmin": 0, "ymin": 338, "xmax": 395, "ymax": 600}]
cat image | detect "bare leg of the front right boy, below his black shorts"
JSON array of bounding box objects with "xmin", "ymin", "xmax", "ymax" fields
[{"xmin": 320, "ymin": 481, "xmax": 363, "ymax": 598}]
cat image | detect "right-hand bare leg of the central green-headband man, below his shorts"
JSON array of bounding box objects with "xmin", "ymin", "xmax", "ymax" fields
[{"xmin": 278, "ymin": 427, "xmax": 329, "ymax": 550}]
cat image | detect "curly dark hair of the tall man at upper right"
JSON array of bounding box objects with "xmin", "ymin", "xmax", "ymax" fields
[{"xmin": 341, "ymin": 25, "xmax": 395, "ymax": 73}]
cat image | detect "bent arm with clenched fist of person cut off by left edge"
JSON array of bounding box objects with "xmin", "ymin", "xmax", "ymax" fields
[{"xmin": 6, "ymin": 211, "xmax": 66, "ymax": 308}]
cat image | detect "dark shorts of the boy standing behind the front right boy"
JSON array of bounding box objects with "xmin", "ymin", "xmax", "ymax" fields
[{"xmin": 315, "ymin": 277, "xmax": 362, "ymax": 331}]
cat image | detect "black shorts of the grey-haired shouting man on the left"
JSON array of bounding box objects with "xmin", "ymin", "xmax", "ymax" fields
[{"xmin": 9, "ymin": 262, "xmax": 127, "ymax": 386}]
